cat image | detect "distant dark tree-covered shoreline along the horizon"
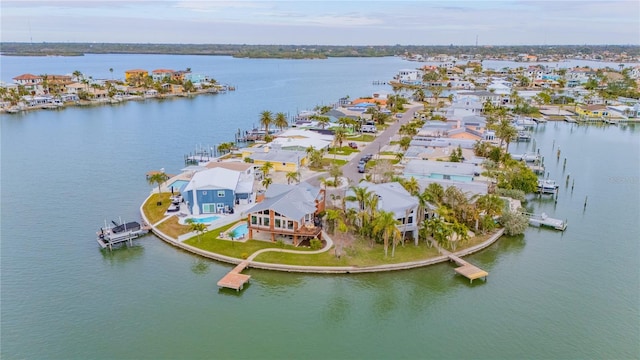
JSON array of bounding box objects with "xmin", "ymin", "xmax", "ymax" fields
[{"xmin": 0, "ymin": 42, "xmax": 640, "ymax": 62}]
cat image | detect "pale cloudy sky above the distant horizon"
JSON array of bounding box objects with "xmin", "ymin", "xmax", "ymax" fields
[{"xmin": 0, "ymin": 0, "xmax": 640, "ymax": 45}]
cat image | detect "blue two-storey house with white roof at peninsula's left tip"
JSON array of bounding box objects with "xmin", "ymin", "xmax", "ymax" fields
[{"xmin": 182, "ymin": 167, "xmax": 255, "ymax": 215}]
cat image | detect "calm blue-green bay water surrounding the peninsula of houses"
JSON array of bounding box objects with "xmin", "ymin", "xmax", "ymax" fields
[{"xmin": 0, "ymin": 55, "xmax": 640, "ymax": 359}]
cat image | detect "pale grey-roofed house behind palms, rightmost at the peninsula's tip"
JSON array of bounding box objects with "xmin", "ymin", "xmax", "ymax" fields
[{"xmin": 345, "ymin": 181, "xmax": 418, "ymax": 242}]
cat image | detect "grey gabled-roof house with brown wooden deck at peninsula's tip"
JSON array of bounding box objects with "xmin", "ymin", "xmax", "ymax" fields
[{"xmin": 247, "ymin": 182, "xmax": 325, "ymax": 246}]
